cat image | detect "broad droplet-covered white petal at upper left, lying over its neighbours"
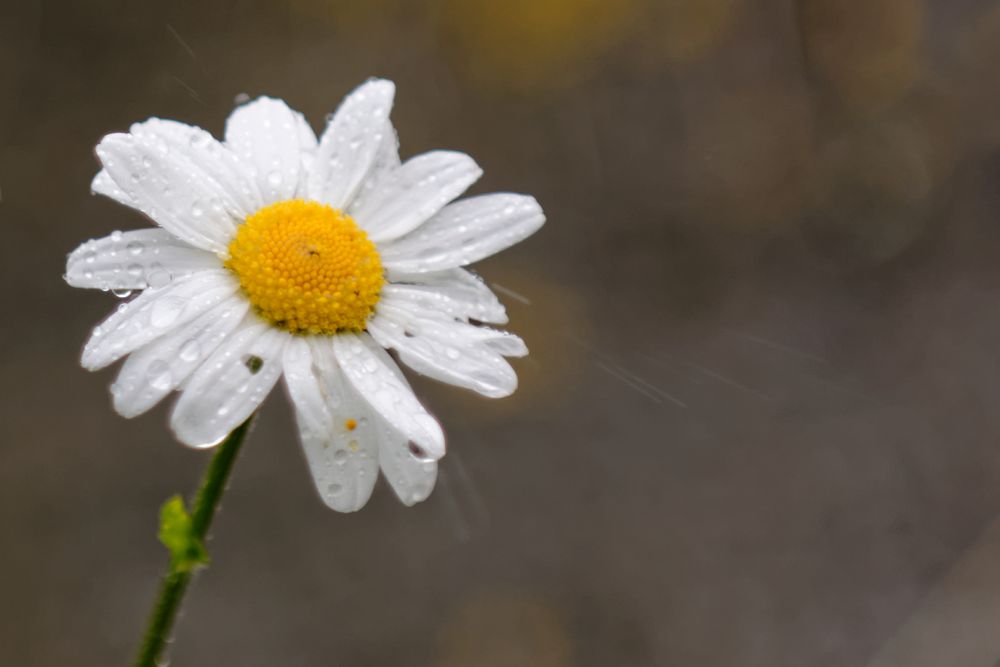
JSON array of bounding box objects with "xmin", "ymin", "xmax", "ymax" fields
[{"xmin": 97, "ymin": 134, "xmax": 236, "ymax": 255}]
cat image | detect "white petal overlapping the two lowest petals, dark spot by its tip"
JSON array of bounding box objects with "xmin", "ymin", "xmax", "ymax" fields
[{"xmin": 333, "ymin": 334, "xmax": 444, "ymax": 459}]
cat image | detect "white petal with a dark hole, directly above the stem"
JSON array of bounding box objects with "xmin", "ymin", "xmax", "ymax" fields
[{"xmin": 170, "ymin": 317, "xmax": 291, "ymax": 447}]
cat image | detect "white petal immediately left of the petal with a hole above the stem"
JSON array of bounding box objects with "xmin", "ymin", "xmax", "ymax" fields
[{"xmin": 111, "ymin": 295, "xmax": 250, "ymax": 417}]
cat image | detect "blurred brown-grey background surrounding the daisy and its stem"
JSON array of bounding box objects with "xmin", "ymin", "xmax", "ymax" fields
[{"xmin": 0, "ymin": 0, "xmax": 1000, "ymax": 667}]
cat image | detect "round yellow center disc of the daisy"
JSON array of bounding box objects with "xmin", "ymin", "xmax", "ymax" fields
[{"xmin": 226, "ymin": 199, "xmax": 385, "ymax": 334}]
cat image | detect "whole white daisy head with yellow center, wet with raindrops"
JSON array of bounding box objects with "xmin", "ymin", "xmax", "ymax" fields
[{"xmin": 66, "ymin": 80, "xmax": 545, "ymax": 512}]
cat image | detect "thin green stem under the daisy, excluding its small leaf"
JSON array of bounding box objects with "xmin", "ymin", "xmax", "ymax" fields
[{"xmin": 133, "ymin": 415, "xmax": 253, "ymax": 667}]
